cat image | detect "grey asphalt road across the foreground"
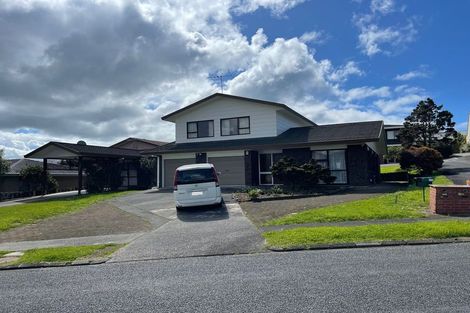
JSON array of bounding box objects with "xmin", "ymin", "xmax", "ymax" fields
[{"xmin": 0, "ymin": 244, "xmax": 470, "ymax": 312}]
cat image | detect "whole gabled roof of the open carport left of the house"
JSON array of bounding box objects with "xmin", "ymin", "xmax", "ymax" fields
[{"xmin": 25, "ymin": 141, "xmax": 140, "ymax": 159}]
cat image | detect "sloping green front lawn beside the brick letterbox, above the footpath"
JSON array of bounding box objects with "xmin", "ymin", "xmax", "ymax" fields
[{"xmin": 264, "ymin": 176, "xmax": 452, "ymax": 226}]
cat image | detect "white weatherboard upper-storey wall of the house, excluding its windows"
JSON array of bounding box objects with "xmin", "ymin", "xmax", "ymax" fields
[{"xmin": 174, "ymin": 98, "xmax": 304, "ymax": 143}]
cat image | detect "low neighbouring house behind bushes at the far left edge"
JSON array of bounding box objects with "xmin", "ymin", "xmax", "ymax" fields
[{"xmin": 0, "ymin": 159, "xmax": 78, "ymax": 199}]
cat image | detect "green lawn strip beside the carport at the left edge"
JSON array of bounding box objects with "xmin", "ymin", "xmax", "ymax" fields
[{"xmin": 0, "ymin": 192, "xmax": 127, "ymax": 231}]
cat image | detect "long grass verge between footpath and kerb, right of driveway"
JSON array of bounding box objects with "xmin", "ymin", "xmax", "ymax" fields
[{"xmin": 263, "ymin": 221, "xmax": 470, "ymax": 248}]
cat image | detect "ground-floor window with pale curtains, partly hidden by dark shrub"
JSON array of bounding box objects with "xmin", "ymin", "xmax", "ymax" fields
[{"xmin": 312, "ymin": 150, "xmax": 348, "ymax": 184}]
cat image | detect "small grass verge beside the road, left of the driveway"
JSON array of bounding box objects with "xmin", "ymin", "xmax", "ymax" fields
[{"xmin": 8, "ymin": 244, "xmax": 123, "ymax": 265}]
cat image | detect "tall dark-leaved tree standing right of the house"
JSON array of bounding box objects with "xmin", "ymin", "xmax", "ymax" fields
[{"xmin": 398, "ymin": 98, "xmax": 457, "ymax": 148}]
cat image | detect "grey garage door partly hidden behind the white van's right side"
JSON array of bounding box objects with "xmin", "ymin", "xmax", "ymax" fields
[{"xmin": 208, "ymin": 156, "xmax": 245, "ymax": 185}]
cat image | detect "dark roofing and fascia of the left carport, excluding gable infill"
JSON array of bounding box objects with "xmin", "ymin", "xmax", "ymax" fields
[{"xmin": 25, "ymin": 141, "xmax": 140, "ymax": 158}]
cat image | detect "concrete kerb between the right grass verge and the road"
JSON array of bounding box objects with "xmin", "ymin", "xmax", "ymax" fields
[{"xmin": 266, "ymin": 237, "xmax": 470, "ymax": 252}]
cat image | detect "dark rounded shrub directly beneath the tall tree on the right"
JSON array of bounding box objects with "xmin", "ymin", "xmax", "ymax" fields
[{"xmin": 400, "ymin": 147, "xmax": 443, "ymax": 175}]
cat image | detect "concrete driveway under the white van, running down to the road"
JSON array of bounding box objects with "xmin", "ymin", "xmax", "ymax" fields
[{"xmin": 111, "ymin": 191, "xmax": 264, "ymax": 262}]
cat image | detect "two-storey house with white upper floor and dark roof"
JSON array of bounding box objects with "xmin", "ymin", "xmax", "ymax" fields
[{"xmin": 142, "ymin": 93, "xmax": 386, "ymax": 188}]
